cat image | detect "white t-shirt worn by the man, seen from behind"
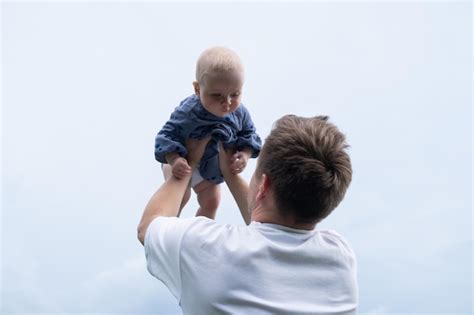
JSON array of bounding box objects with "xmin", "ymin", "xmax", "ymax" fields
[{"xmin": 145, "ymin": 217, "xmax": 358, "ymax": 315}]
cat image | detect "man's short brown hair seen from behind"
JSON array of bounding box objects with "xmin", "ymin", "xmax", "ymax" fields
[{"xmin": 257, "ymin": 115, "xmax": 352, "ymax": 223}]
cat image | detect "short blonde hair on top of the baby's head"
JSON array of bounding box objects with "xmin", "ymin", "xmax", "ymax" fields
[{"xmin": 196, "ymin": 46, "xmax": 244, "ymax": 84}]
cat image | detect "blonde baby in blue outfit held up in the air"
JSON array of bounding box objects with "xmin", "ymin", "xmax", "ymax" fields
[{"xmin": 155, "ymin": 47, "xmax": 261, "ymax": 219}]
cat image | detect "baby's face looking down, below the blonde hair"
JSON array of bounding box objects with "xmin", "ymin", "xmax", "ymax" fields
[{"xmin": 194, "ymin": 73, "xmax": 244, "ymax": 117}]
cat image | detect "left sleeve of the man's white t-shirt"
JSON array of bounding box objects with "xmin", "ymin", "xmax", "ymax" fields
[{"xmin": 145, "ymin": 217, "xmax": 196, "ymax": 301}]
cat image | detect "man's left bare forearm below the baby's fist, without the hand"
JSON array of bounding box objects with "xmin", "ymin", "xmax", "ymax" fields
[{"xmin": 138, "ymin": 175, "xmax": 191, "ymax": 244}]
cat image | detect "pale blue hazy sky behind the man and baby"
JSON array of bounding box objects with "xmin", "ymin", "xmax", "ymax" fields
[{"xmin": 0, "ymin": 1, "xmax": 473, "ymax": 314}]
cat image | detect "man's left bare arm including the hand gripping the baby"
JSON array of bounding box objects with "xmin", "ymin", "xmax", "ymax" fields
[{"xmin": 137, "ymin": 137, "xmax": 210, "ymax": 244}]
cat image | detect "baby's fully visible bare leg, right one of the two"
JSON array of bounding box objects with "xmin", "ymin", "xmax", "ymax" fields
[{"xmin": 194, "ymin": 180, "xmax": 221, "ymax": 219}]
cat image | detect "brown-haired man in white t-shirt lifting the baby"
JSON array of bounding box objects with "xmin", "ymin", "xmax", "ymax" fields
[{"xmin": 138, "ymin": 115, "xmax": 357, "ymax": 314}]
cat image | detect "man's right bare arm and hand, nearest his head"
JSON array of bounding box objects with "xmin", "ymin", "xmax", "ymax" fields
[{"xmin": 219, "ymin": 143, "xmax": 250, "ymax": 225}]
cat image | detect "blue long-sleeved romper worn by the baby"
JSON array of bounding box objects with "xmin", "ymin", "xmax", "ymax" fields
[{"xmin": 155, "ymin": 95, "xmax": 262, "ymax": 184}]
